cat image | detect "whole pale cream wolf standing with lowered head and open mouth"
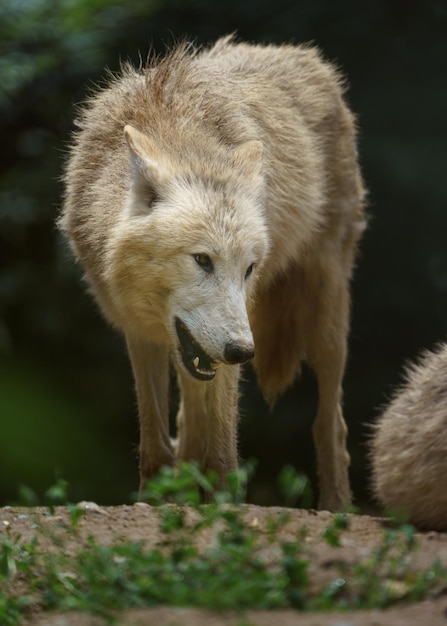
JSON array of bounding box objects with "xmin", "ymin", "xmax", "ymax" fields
[{"xmin": 60, "ymin": 38, "xmax": 365, "ymax": 509}]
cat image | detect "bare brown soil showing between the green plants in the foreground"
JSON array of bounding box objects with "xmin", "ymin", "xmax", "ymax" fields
[{"xmin": 0, "ymin": 503, "xmax": 447, "ymax": 626}]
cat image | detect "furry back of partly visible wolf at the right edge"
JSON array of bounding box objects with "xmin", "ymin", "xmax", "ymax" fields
[{"xmin": 371, "ymin": 344, "xmax": 447, "ymax": 531}]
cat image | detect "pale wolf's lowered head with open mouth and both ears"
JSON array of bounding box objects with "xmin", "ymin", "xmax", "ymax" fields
[{"xmin": 108, "ymin": 126, "xmax": 268, "ymax": 380}]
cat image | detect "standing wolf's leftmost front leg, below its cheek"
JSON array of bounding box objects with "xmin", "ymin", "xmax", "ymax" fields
[{"xmin": 126, "ymin": 335, "xmax": 174, "ymax": 491}]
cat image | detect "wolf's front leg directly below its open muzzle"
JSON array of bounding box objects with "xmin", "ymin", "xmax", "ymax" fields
[{"xmin": 177, "ymin": 365, "xmax": 239, "ymax": 488}]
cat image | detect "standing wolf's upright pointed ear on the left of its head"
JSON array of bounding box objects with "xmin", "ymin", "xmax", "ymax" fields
[{"xmin": 124, "ymin": 125, "xmax": 169, "ymax": 205}]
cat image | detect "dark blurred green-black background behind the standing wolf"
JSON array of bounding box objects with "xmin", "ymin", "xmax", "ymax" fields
[{"xmin": 0, "ymin": 0, "xmax": 447, "ymax": 506}]
